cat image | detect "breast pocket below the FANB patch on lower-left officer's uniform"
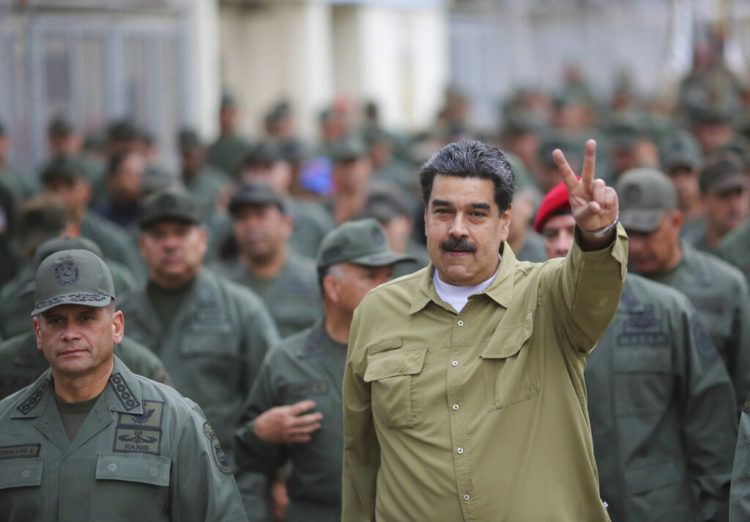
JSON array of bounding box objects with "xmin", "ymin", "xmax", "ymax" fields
[{"xmin": 92, "ymin": 454, "xmax": 171, "ymax": 521}]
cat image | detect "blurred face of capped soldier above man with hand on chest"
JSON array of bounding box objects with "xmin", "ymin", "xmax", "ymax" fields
[{"xmin": 232, "ymin": 205, "xmax": 292, "ymax": 263}]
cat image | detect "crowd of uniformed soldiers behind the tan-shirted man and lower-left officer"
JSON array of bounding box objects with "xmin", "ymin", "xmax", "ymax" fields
[{"xmin": 0, "ymin": 44, "xmax": 750, "ymax": 521}]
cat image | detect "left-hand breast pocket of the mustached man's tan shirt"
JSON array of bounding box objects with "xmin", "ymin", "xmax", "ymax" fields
[{"xmin": 364, "ymin": 348, "xmax": 427, "ymax": 428}]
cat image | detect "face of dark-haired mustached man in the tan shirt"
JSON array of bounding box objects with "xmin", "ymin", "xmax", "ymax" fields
[{"xmin": 425, "ymin": 175, "xmax": 510, "ymax": 286}]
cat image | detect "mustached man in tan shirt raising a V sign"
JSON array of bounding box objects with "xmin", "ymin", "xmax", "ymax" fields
[{"xmin": 342, "ymin": 140, "xmax": 627, "ymax": 522}]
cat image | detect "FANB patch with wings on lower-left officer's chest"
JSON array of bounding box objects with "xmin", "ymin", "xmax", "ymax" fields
[{"xmin": 112, "ymin": 401, "xmax": 164, "ymax": 455}]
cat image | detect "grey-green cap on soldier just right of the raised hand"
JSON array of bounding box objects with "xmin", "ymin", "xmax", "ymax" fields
[{"xmin": 615, "ymin": 168, "xmax": 677, "ymax": 233}]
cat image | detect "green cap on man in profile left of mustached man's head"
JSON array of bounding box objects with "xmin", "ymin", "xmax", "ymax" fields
[{"xmin": 317, "ymin": 219, "xmax": 413, "ymax": 269}]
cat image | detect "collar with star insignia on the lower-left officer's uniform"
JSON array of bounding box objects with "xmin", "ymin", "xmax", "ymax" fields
[{"xmin": 11, "ymin": 356, "xmax": 143, "ymax": 419}]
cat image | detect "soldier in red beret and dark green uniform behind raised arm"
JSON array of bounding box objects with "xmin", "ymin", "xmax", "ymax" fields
[{"xmin": 534, "ymin": 183, "xmax": 736, "ymax": 522}]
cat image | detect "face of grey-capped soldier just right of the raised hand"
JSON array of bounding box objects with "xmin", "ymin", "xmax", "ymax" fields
[{"xmin": 627, "ymin": 211, "xmax": 681, "ymax": 274}]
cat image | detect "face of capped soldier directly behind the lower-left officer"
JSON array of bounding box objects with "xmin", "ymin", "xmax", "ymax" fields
[{"xmin": 139, "ymin": 220, "xmax": 207, "ymax": 288}]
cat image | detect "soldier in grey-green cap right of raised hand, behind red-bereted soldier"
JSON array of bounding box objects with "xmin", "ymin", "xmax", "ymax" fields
[{"xmin": 616, "ymin": 169, "xmax": 750, "ymax": 410}]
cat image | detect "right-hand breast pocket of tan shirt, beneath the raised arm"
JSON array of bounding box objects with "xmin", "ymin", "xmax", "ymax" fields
[{"xmin": 480, "ymin": 313, "xmax": 541, "ymax": 410}]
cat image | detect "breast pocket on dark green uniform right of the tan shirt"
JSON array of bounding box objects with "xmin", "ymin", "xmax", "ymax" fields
[{"xmin": 612, "ymin": 347, "xmax": 673, "ymax": 417}]
